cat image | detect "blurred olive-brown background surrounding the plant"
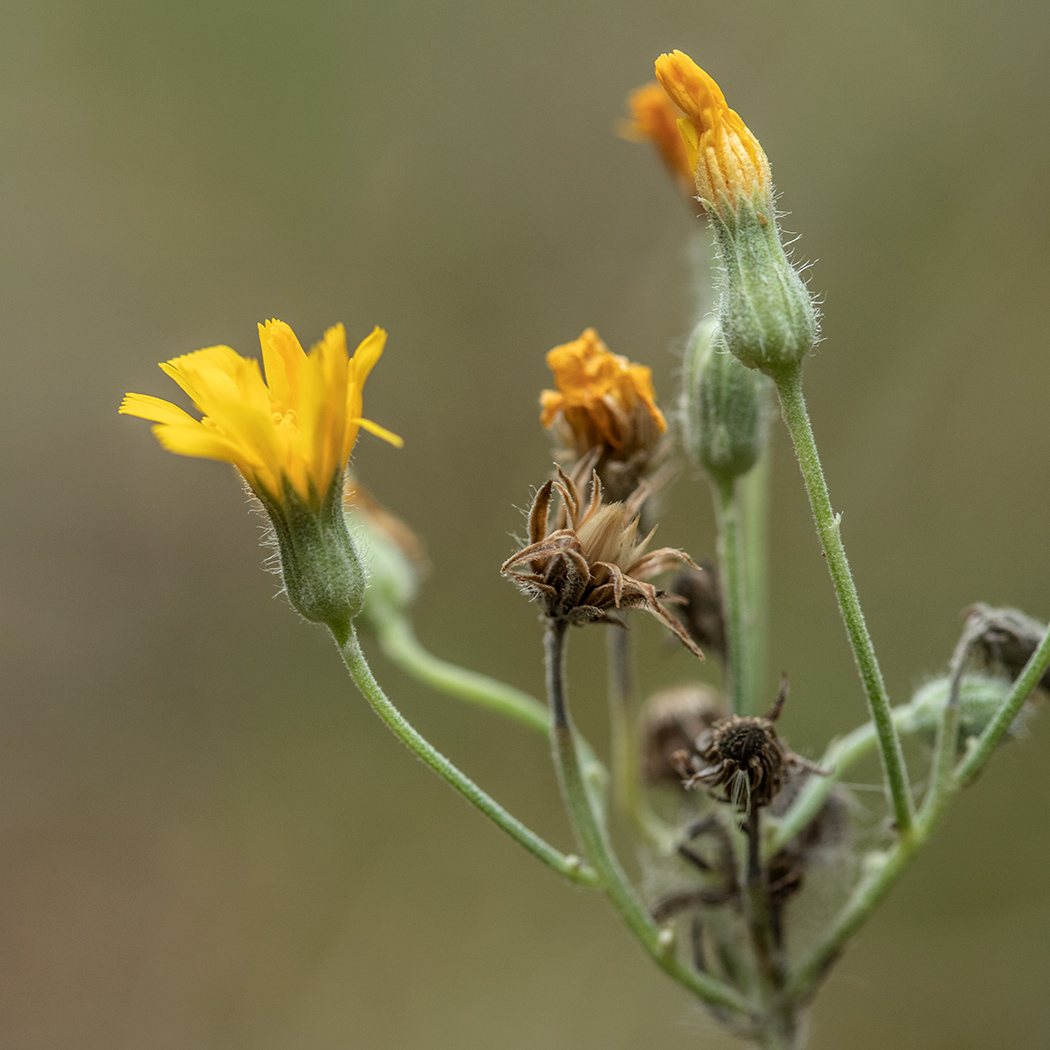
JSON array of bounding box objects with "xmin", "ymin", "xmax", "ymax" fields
[{"xmin": 6, "ymin": 0, "xmax": 1050, "ymax": 1050}]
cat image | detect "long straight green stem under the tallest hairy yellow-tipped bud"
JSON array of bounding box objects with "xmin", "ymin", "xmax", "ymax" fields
[{"xmin": 773, "ymin": 365, "xmax": 915, "ymax": 838}]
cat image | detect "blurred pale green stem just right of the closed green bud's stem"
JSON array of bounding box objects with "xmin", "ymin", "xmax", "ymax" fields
[{"xmin": 740, "ymin": 438, "xmax": 773, "ymax": 714}]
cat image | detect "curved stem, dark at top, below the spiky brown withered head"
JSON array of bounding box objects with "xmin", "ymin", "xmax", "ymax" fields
[{"xmin": 544, "ymin": 620, "xmax": 750, "ymax": 1014}]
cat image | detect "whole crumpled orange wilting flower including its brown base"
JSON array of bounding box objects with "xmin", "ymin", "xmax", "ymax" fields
[{"xmin": 540, "ymin": 329, "xmax": 667, "ymax": 500}]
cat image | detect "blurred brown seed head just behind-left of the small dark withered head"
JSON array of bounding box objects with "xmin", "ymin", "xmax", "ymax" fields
[{"xmin": 642, "ymin": 681, "xmax": 727, "ymax": 786}]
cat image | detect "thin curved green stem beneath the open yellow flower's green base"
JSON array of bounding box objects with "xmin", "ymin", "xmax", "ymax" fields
[{"xmin": 336, "ymin": 625, "xmax": 599, "ymax": 886}]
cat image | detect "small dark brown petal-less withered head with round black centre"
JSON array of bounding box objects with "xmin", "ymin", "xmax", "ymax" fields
[{"xmin": 674, "ymin": 678, "xmax": 825, "ymax": 812}]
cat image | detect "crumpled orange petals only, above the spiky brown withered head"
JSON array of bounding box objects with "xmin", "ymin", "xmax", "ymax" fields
[{"xmin": 540, "ymin": 329, "xmax": 667, "ymax": 448}]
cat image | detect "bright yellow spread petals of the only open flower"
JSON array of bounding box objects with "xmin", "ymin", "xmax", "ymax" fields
[{"xmin": 120, "ymin": 320, "xmax": 402, "ymax": 509}]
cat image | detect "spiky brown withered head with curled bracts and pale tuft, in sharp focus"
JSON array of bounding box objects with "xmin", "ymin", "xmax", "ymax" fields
[{"xmin": 500, "ymin": 467, "xmax": 704, "ymax": 659}]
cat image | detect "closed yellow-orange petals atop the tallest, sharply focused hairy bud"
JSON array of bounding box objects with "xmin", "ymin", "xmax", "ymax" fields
[{"xmin": 656, "ymin": 51, "xmax": 773, "ymax": 212}]
